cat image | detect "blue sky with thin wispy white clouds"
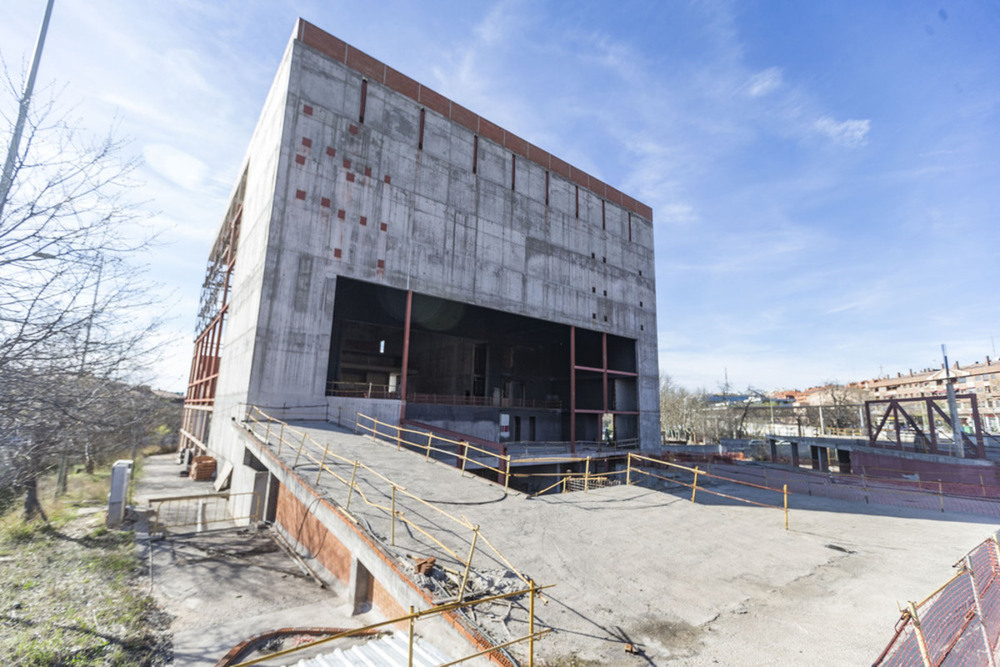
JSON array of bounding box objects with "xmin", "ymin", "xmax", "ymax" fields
[{"xmin": 0, "ymin": 0, "xmax": 1000, "ymax": 390}]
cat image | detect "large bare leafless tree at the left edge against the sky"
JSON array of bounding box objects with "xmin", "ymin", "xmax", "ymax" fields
[{"xmin": 0, "ymin": 72, "xmax": 158, "ymax": 517}]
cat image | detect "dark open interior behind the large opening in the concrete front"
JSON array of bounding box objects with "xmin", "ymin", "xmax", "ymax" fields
[{"xmin": 327, "ymin": 276, "xmax": 638, "ymax": 442}]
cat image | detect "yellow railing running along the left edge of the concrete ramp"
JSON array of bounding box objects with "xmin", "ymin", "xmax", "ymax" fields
[{"xmin": 245, "ymin": 407, "xmax": 529, "ymax": 588}]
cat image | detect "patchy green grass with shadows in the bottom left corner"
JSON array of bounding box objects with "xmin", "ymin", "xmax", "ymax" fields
[{"xmin": 0, "ymin": 480, "xmax": 169, "ymax": 667}]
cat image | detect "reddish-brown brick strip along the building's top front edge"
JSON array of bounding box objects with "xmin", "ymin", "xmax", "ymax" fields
[{"xmin": 296, "ymin": 19, "xmax": 653, "ymax": 223}]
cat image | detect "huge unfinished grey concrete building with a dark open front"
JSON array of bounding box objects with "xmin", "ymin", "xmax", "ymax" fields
[{"xmin": 183, "ymin": 21, "xmax": 659, "ymax": 470}]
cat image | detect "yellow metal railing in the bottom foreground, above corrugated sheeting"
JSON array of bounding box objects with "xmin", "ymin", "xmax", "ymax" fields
[{"xmin": 231, "ymin": 581, "xmax": 552, "ymax": 667}]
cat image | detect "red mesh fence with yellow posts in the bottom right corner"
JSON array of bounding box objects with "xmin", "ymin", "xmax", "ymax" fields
[{"xmin": 875, "ymin": 536, "xmax": 1000, "ymax": 667}]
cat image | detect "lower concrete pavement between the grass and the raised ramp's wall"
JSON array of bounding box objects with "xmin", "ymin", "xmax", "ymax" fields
[{"xmin": 133, "ymin": 455, "xmax": 382, "ymax": 667}]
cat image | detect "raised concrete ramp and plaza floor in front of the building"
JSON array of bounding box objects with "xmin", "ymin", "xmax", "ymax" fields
[{"xmin": 252, "ymin": 423, "xmax": 996, "ymax": 665}]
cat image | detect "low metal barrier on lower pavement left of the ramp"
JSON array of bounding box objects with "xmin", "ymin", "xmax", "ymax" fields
[{"xmin": 146, "ymin": 491, "xmax": 260, "ymax": 533}]
